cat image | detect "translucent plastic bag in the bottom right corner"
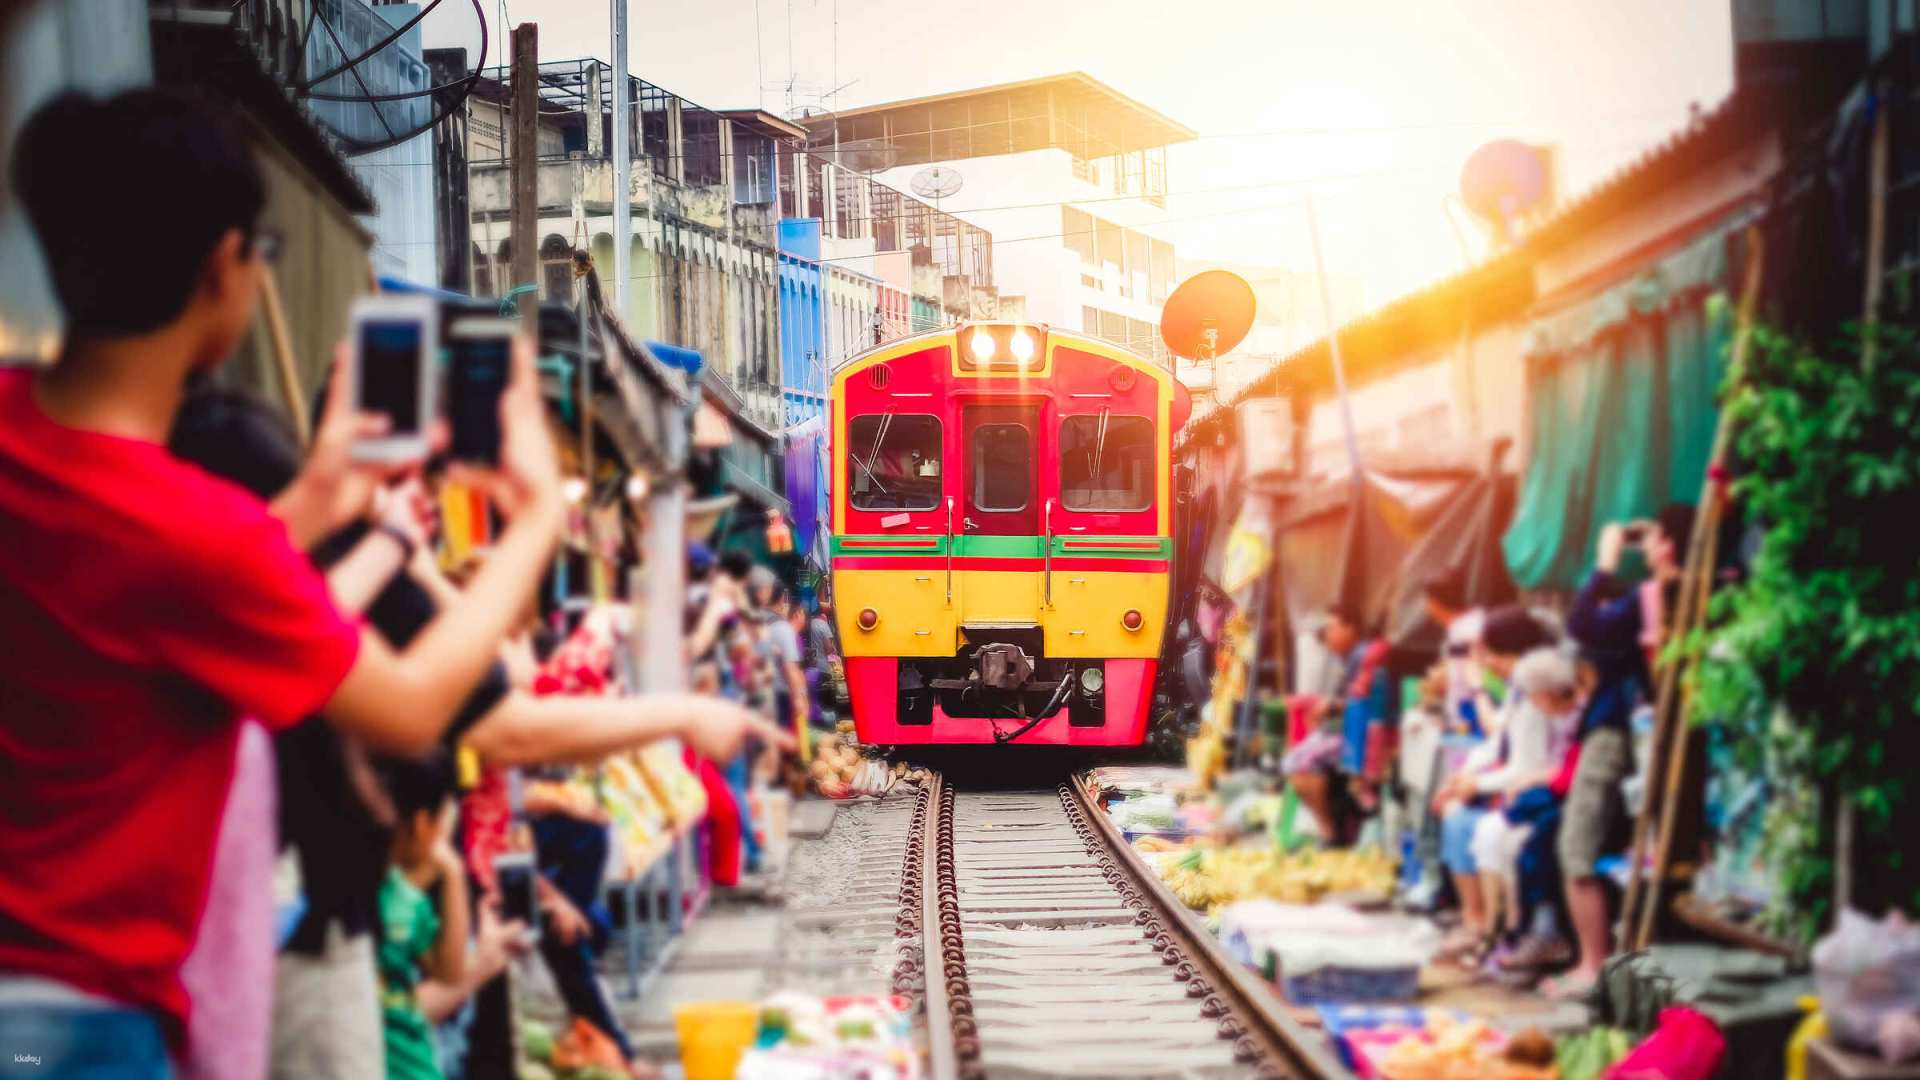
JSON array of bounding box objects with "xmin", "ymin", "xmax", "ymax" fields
[{"xmin": 1812, "ymin": 909, "xmax": 1920, "ymax": 1051}]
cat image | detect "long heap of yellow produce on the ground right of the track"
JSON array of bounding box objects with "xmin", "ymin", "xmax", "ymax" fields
[{"xmin": 1160, "ymin": 846, "xmax": 1396, "ymax": 911}]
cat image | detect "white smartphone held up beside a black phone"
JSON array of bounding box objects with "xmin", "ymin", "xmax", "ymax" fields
[{"xmin": 349, "ymin": 296, "xmax": 440, "ymax": 461}]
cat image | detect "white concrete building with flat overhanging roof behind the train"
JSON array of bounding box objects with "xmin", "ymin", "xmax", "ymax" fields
[{"xmin": 803, "ymin": 73, "xmax": 1194, "ymax": 359}]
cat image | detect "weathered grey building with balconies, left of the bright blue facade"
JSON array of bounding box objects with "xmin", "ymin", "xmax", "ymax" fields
[{"xmin": 467, "ymin": 60, "xmax": 799, "ymax": 430}]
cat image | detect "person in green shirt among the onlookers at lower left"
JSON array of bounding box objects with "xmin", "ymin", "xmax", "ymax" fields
[{"xmin": 376, "ymin": 753, "xmax": 467, "ymax": 1080}]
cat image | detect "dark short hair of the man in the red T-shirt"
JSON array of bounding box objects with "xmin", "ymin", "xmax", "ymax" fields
[{"xmin": 13, "ymin": 88, "xmax": 267, "ymax": 334}]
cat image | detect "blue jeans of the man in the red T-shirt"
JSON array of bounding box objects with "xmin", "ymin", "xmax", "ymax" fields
[{"xmin": 0, "ymin": 1005, "xmax": 173, "ymax": 1080}]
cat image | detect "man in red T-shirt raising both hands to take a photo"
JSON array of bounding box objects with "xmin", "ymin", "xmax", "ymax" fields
[{"xmin": 0, "ymin": 90, "xmax": 563, "ymax": 1076}]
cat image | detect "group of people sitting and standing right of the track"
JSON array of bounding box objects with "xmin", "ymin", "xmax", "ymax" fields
[{"xmin": 1283, "ymin": 505, "xmax": 1692, "ymax": 999}]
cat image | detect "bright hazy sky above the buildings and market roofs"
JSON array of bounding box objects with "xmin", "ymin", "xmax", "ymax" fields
[{"xmin": 428, "ymin": 0, "xmax": 1732, "ymax": 311}]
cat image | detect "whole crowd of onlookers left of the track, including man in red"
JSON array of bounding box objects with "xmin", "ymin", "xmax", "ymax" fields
[{"xmin": 0, "ymin": 90, "xmax": 810, "ymax": 1080}]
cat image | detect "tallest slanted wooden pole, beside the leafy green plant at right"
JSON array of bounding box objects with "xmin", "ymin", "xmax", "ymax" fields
[{"xmin": 1620, "ymin": 227, "xmax": 1764, "ymax": 949}]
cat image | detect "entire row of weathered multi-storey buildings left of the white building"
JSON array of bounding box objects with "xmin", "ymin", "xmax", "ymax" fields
[{"xmin": 467, "ymin": 60, "xmax": 993, "ymax": 432}]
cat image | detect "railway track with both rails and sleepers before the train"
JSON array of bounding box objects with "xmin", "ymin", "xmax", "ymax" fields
[{"xmin": 893, "ymin": 776, "xmax": 1346, "ymax": 1080}]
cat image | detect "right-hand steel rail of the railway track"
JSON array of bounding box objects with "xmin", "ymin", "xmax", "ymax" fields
[{"xmin": 1060, "ymin": 776, "xmax": 1352, "ymax": 1080}]
